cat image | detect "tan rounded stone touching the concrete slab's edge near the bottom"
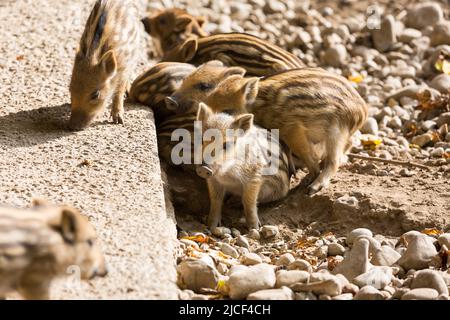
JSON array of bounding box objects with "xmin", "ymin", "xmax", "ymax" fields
[{"xmin": 177, "ymin": 259, "xmax": 220, "ymax": 292}]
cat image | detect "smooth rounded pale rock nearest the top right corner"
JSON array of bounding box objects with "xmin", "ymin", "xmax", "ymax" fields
[{"xmin": 406, "ymin": 2, "xmax": 444, "ymax": 30}]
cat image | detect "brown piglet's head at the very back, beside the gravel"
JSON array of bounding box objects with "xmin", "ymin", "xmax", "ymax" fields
[{"xmin": 142, "ymin": 8, "xmax": 208, "ymax": 56}]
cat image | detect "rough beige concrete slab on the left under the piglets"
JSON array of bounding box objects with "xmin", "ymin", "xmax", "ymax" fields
[{"xmin": 0, "ymin": 0, "xmax": 177, "ymax": 299}]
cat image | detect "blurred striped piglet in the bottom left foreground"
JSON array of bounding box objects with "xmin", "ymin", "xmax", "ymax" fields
[{"xmin": 0, "ymin": 205, "xmax": 106, "ymax": 300}]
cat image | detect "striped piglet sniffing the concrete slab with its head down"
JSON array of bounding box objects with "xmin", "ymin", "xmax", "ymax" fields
[{"xmin": 69, "ymin": 0, "xmax": 140, "ymax": 130}]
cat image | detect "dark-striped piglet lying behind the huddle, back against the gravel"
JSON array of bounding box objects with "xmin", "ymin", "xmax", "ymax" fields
[{"xmin": 163, "ymin": 33, "xmax": 305, "ymax": 76}]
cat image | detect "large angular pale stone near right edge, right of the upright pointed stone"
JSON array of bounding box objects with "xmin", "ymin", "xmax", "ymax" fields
[{"xmin": 397, "ymin": 231, "xmax": 437, "ymax": 270}]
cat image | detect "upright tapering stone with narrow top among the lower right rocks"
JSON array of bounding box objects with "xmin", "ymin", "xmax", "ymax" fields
[{"xmin": 333, "ymin": 238, "xmax": 371, "ymax": 281}]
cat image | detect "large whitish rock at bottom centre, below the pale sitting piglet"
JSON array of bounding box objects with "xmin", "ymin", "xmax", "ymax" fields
[{"xmin": 228, "ymin": 263, "xmax": 276, "ymax": 299}]
